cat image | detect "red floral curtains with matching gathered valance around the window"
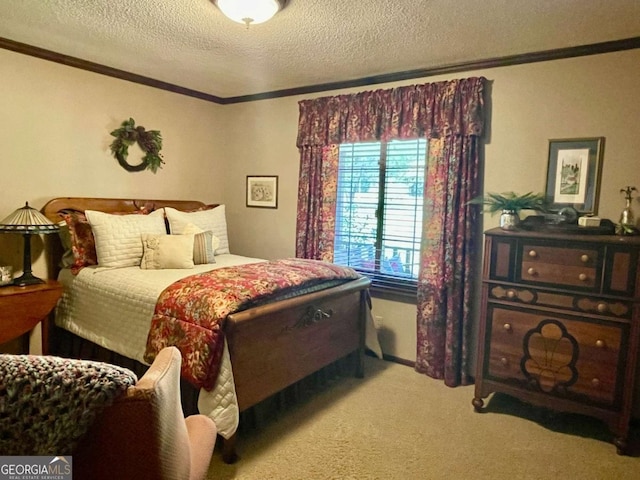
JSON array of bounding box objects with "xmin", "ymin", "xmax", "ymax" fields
[{"xmin": 296, "ymin": 77, "xmax": 486, "ymax": 385}]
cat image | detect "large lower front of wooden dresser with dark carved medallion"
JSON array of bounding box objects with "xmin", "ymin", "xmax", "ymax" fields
[{"xmin": 485, "ymin": 305, "xmax": 629, "ymax": 405}]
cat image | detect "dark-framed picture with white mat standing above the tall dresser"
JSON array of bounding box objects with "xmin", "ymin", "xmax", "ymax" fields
[{"xmin": 545, "ymin": 137, "xmax": 604, "ymax": 215}]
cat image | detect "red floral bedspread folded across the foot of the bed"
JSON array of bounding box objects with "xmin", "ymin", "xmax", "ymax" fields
[{"xmin": 144, "ymin": 258, "xmax": 360, "ymax": 390}]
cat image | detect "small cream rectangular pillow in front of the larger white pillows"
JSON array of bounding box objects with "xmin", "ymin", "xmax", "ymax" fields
[{"xmin": 140, "ymin": 234, "xmax": 194, "ymax": 270}]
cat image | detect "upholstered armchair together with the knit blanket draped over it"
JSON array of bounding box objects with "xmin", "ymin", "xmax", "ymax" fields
[{"xmin": 0, "ymin": 347, "xmax": 217, "ymax": 480}]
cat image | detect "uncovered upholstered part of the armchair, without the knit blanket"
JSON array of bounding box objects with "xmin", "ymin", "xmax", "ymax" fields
[{"xmin": 73, "ymin": 347, "xmax": 216, "ymax": 480}]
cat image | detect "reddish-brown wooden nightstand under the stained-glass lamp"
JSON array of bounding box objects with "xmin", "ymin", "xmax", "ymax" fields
[{"xmin": 0, "ymin": 280, "xmax": 62, "ymax": 355}]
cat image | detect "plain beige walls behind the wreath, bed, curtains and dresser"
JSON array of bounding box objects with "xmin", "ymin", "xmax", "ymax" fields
[{"xmin": 0, "ymin": 46, "xmax": 640, "ymax": 361}]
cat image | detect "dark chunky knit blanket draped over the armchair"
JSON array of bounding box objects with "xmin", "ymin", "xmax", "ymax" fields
[{"xmin": 0, "ymin": 354, "xmax": 137, "ymax": 455}]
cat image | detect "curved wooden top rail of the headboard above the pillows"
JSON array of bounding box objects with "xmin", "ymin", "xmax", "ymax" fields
[{"xmin": 41, "ymin": 197, "xmax": 210, "ymax": 223}]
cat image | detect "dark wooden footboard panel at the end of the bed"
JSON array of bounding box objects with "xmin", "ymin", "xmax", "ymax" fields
[{"xmin": 225, "ymin": 278, "xmax": 369, "ymax": 411}]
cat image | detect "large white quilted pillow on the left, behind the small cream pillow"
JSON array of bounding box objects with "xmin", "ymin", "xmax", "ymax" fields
[{"xmin": 85, "ymin": 210, "xmax": 167, "ymax": 267}]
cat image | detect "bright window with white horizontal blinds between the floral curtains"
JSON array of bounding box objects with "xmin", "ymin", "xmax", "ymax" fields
[{"xmin": 333, "ymin": 139, "xmax": 426, "ymax": 296}]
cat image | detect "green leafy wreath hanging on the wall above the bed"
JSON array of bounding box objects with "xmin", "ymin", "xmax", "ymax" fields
[{"xmin": 110, "ymin": 118, "xmax": 164, "ymax": 173}]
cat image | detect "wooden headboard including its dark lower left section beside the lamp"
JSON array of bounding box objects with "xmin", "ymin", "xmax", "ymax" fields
[{"xmin": 41, "ymin": 197, "xmax": 214, "ymax": 278}]
